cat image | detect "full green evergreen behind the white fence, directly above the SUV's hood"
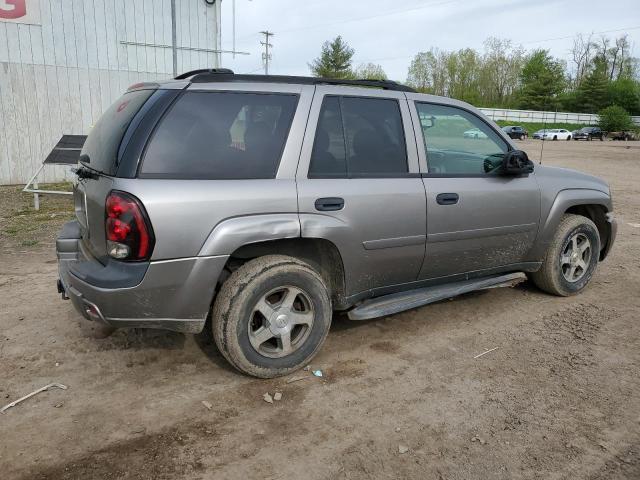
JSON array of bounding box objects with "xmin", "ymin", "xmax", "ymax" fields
[{"xmin": 518, "ymin": 50, "xmax": 566, "ymax": 110}]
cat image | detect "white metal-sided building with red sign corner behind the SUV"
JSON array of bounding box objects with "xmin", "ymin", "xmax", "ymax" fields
[{"xmin": 0, "ymin": 0, "xmax": 221, "ymax": 184}]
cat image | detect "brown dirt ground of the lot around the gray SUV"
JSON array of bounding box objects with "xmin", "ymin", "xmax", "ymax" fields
[{"xmin": 0, "ymin": 141, "xmax": 640, "ymax": 480}]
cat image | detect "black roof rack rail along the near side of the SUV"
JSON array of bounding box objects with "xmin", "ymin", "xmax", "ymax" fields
[{"xmin": 185, "ymin": 68, "xmax": 415, "ymax": 92}]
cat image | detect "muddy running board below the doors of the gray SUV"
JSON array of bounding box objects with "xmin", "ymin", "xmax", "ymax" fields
[{"xmin": 348, "ymin": 273, "xmax": 525, "ymax": 320}]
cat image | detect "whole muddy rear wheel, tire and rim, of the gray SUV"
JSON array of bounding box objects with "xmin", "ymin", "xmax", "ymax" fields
[{"xmin": 211, "ymin": 255, "xmax": 332, "ymax": 378}]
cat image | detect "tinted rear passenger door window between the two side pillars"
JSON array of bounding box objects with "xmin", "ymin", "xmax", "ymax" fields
[{"xmin": 309, "ymin": 96, "xmax": 408, "ymax": 178}]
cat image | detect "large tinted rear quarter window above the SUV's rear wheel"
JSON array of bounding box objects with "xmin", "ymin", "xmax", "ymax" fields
[{"xmin": 140, "ymin": 92, "xmax": 298, "ymax": 180}]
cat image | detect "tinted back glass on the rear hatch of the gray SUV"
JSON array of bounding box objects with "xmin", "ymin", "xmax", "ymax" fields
[{"xmin": 80, "ymin": 90, "xmax": 154, "ymax": 175}]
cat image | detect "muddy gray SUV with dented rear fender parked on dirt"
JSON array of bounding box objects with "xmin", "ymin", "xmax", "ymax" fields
[{"xmin": 57, "ymin": 70, "xmax": 616, "ymax": 377}]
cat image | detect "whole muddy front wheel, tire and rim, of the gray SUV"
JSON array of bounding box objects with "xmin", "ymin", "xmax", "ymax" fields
[{"xmin": 529, "ymin": 215, "xmax": 600, "ymax": 297}]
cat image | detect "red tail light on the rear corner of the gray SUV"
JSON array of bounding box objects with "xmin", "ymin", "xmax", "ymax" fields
[{"xmin": 105, "ymin": 190, "xmax": 155, "ymax": 261}]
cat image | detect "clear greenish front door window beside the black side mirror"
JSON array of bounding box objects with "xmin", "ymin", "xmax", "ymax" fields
[{"xmin": 416, "ymin": 103, "xmax": 508, "ymax": 175}]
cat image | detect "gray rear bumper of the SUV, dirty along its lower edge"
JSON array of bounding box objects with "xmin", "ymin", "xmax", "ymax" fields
[{"xmin": 56, "ymin": 221, "xmax": 228, "ymax": 333}]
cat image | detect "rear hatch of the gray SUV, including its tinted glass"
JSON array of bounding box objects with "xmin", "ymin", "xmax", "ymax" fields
[{"xmin": 74, "ymin": 90, "xmax": 154, "ymax": 260}]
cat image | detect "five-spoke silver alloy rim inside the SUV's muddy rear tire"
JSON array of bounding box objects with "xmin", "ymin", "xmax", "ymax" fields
[{"xmin": 248, "ymin": 285, "xmax": 315, "ymax": 358}]
